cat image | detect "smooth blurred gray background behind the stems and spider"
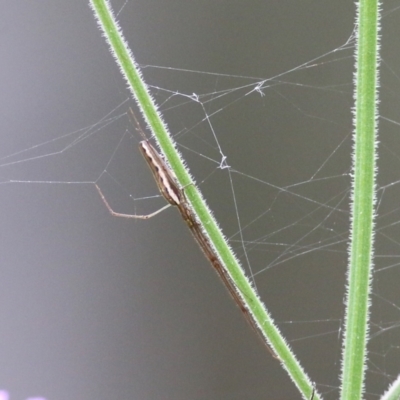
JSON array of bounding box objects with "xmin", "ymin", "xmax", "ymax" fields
[{"xmin": 0, "ymin": 0, "xmax": 400, "ymax": 400}]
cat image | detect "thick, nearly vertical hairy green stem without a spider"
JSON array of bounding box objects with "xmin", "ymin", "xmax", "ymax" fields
[{"xmin": 341, "ymin": 0, "xmax": 379, "ymax": 400}]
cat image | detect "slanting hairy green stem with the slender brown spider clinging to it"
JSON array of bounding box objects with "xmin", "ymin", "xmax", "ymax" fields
[{"xmin": 90, "ymin": 0, "xmax": 320, "ymax": 400}]
